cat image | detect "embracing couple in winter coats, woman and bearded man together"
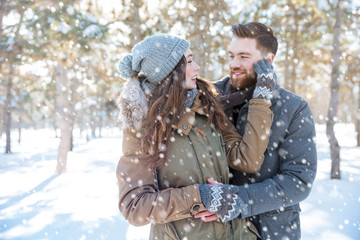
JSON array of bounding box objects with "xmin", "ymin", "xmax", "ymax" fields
[{"xmin": 117, "ymin": 22, "xmax": 316, "ymax": 240}]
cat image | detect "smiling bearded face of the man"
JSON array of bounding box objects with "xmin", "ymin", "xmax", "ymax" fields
[{"xmin": 229, "ymin": 37, "xmax": 264, "ymax": 89}]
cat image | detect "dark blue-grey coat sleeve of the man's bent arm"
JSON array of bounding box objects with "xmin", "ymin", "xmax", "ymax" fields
[{"xmin": 235, "ymin": 101, "xmax": 317, "ymax": 218}]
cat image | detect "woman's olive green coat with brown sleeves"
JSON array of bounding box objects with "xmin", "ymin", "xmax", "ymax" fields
[{"xmin": 117, "ymin": 97, "xmax": 273, "ymax": 240}]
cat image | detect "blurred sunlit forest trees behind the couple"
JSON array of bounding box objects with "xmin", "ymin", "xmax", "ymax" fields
[{"xmin": 0, "ymin": 0, "xmax": 360, "ymax": 172}]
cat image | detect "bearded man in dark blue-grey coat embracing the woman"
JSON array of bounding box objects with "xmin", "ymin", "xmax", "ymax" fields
[{"xmin": 197, "ymin": 22, "xmax": 317, "ymax": 240}]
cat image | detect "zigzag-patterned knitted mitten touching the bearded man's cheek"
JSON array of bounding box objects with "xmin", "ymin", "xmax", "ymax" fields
[{"xmin": 253, "ymin": 59, "xmax": 276, "ymax": 100}]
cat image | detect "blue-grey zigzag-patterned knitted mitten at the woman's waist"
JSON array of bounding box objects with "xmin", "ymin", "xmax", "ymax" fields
[{"xmin": 199, "ymin": 184, "xmax": 247, "ymax": 222}]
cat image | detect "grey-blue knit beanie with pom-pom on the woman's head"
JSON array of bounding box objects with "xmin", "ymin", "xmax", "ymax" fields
[{"xmin": 118, "ymin": 34, "xmax": 190, "ymax": 83}]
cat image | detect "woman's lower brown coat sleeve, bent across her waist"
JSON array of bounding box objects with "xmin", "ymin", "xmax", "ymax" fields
[{"xmin": 116, "ymin": 126, "xmax": 205, "ymax": 226}]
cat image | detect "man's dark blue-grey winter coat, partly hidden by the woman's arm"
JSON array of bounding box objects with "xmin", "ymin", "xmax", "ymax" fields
[{"xmin": 214, "ymin": 77, "xmax": 317, "ymax": 240}]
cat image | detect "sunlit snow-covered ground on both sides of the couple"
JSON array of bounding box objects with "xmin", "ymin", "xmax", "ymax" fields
[{"xmin": 0, "ymin": 124, "xmax": 360, "ymax": 240}]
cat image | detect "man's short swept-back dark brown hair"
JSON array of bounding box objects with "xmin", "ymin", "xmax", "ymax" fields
[{"xmin": 231, "ymin": 22, "xmax": 278, "ymax": 55}]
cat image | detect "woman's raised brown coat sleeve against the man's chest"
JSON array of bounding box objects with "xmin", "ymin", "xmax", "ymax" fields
[{"xmin": 222, "ymin": 99, "xmax": 274, "ymax": 173}]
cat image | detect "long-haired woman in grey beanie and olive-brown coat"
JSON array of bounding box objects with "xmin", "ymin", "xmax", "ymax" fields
[{"xmin": 117, "ymin": 35, "xmax": 273, "ymax": 239}]
